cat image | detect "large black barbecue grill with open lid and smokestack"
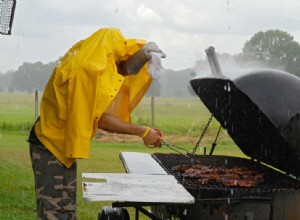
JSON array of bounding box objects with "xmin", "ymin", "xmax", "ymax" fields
[{"xmin": 149, "ymin": 47, "xmax": 300, "ymax": 219}]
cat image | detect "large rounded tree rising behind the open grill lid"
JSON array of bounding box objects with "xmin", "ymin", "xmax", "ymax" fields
[{"xmin": 242, "ymin": 30, "xmax": 300, "ymax": 76}]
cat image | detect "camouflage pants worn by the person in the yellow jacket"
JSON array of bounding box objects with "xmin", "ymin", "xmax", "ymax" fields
[{"xmin": 30, "ymin": 143, "xmax": 77, "ymax": 220}]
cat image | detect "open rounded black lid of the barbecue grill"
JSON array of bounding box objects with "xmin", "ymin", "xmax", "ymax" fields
[{"xmin": 191, "ymin": 70, "xmax": 300, "ymax": 177}]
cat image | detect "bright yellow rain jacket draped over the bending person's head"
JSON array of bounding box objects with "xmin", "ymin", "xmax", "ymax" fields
[{"xmin": 35, "ymin": 28, "xmax": 151, "ymax": 167}]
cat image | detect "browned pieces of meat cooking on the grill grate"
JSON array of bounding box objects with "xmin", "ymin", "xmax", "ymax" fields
[{"xmin": 172, "ymin": 164, "xmax": 263, "ymax": 187}]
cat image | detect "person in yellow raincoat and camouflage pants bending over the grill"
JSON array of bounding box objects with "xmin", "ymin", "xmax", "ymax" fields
[{"xmin": 28, "ymin": 28, "xmax": 166, "ymax": 219}]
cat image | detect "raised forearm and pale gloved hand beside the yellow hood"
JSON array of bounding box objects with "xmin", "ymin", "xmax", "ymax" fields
[{"xmin": 126, "ymin": 42, "xmax": 166, "ymax": 75}]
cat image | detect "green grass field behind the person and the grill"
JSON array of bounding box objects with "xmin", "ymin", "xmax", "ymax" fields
[{"xmin": 0, "ymin": 93, "xmax": 244, "ymax": 220}]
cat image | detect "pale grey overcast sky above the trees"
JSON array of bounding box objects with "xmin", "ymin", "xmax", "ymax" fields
[{"xmin": 0, "ymin": 0, "xmax": 300, "ymax": 73}]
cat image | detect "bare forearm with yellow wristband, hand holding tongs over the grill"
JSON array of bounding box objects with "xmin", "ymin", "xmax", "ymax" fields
[{"xmin": 98, "ymin": 113, "xmax": 162, "ymax": 147}]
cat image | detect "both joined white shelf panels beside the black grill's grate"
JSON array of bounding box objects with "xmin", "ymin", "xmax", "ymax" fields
[{"xmin": 82, "ymin": 152, "xmax": 195, "ymax": 204}]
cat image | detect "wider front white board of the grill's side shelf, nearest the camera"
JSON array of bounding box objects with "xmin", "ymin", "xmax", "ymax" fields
[{"xmin": 82, "ymin": 173, "xmax": 194, "ymax": 204}]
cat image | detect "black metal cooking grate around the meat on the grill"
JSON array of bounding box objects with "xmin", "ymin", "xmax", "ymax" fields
[{"xmin": 153, "ymin": 153, "xmax": 300, "ymax": 199}]
